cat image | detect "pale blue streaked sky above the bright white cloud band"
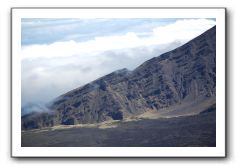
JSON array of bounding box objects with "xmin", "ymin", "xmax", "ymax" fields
[{"xmin": 21, "ymin": 18, "xmax": 181, "ymax": 46}]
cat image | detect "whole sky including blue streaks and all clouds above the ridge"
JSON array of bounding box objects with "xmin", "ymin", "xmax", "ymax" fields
[{"xmin": 20, "ymin": 18, "xmax": 216, "ymax": 106}]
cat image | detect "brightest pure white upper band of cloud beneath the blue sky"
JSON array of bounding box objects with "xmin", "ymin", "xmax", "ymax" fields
[{"xmin": 21, "ymin": 19, "xmax": 215, "ymax": 59}]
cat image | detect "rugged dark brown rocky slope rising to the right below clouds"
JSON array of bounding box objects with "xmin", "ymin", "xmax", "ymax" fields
[{"xmin": 22, "ymin": 27, "xmax": 216, "ymax": 129}]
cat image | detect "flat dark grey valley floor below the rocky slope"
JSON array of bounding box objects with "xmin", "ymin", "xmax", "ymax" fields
[{"xmin": 21, "ymin": 111, "xmax": 216, "ymax": 147}]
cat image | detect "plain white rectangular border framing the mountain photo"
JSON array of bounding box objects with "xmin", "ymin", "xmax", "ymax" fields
[{"xmin": 11, "ymin": 7, "xmax": 227, "ymax": 157}]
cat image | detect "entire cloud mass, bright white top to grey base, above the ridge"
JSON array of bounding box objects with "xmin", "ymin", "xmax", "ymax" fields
[{"xmin": 21, "ymin": 19, "xmax": 215, "ymax": 104}]
